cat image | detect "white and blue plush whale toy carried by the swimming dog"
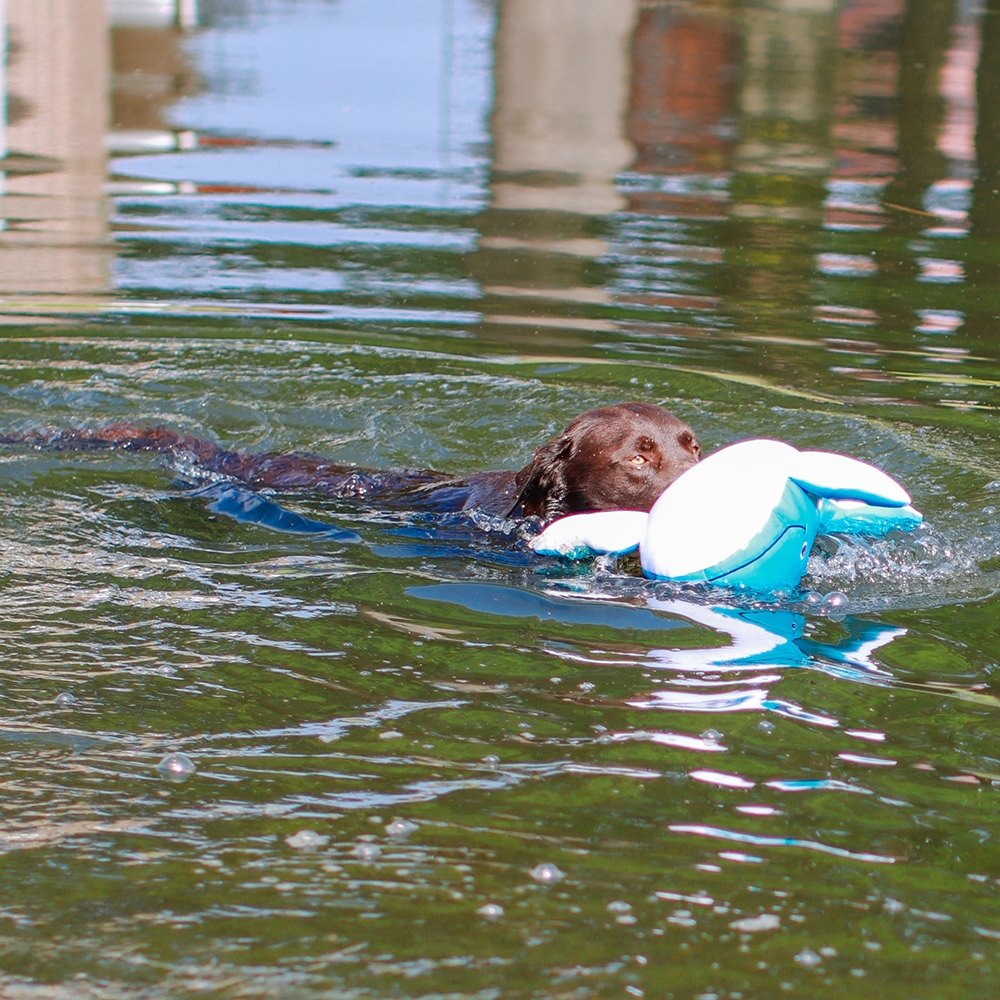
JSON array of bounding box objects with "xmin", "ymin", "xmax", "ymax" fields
[{"xmin": 531, "ymin": 440, "xmax": 923, "ymax": 592}]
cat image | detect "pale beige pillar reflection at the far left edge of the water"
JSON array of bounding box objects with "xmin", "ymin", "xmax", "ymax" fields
[{"xmin": 0, "ymin": 0, "xmax": 111, "ymax": 293}]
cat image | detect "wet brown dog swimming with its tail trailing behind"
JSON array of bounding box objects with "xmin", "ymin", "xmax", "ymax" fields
[{"xmin": 15, "ymin": 403, "xmax": 701, "ymax": 519}]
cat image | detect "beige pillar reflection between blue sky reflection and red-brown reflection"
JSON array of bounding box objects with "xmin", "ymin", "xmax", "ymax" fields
[{"xmin": 468, "ymin": 0, "xmax": 639, "ymax": 334}]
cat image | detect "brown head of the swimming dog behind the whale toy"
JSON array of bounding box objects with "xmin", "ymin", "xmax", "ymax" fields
[{"xmin": 511, "ymin": 403, "xmax": 701, "ymax": 519}]
